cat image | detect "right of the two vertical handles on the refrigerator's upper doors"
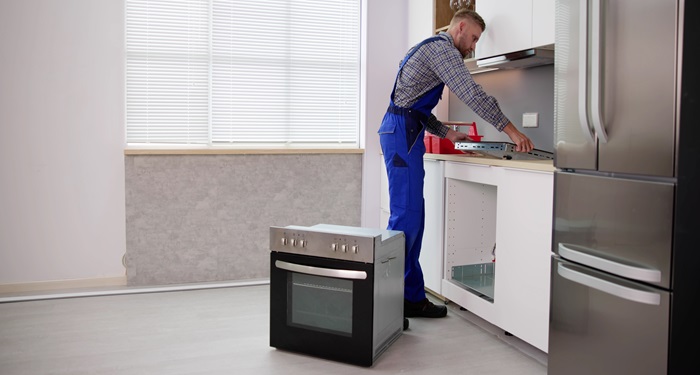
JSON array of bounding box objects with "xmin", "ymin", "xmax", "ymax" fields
[{"xmin": 591, "ymin": 0, "xmax": 608, "ymax": 143}]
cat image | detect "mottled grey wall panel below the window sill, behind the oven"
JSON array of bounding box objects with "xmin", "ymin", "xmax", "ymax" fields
[{"xmin": 125, "ymin": 154, "xmax": 362, "ymax": 286}]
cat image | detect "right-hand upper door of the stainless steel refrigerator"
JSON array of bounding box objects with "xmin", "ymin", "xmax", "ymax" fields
[{"xmin": 591, "ymin": 0, "xmax": 678, "ymax": 177}]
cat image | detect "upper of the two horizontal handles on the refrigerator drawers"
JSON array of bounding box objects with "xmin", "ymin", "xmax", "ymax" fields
[{"xmin": 559, "ymin": 243, "xmax": 661, "ymax": 283}]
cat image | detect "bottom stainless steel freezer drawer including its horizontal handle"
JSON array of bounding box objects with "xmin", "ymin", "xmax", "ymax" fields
[{"xmin": 547, "ymin": 256, "xmax": 671, "ymax": 375}]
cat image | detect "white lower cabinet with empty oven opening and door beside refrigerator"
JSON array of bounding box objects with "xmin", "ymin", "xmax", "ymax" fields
[{"xmin": 442, "ymin": 162, "xmax": 553, "ymax": 352}]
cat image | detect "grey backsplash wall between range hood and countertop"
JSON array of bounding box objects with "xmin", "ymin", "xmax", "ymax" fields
[{"xmin": 450, "ymin": 65, "xmax": 554, "ymax": 152}]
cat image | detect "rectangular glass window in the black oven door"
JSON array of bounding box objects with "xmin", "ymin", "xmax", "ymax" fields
[{"xmin": 287, "ymin": 272, "xmax": 352, "ymax": 337}]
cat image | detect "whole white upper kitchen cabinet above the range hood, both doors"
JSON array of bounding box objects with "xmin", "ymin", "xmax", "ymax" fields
[{"xmin": 475, "ymin": 0, "xmax": 554, "ymax": 58}]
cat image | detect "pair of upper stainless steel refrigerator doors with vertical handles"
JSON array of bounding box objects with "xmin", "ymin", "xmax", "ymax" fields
[{"xmin": 555, "ymin": 0, "xmax": 678, "ymax": 177}]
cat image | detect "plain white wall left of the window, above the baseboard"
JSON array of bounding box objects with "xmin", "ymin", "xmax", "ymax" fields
[{"xmin": 0, "ymin": 0, "xmax": 125, "ymax": 284}]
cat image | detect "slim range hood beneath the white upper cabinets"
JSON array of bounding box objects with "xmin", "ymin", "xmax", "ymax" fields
[{"xmin": 464, "ymin": 45, "xmax": 554, "ymax": 74}]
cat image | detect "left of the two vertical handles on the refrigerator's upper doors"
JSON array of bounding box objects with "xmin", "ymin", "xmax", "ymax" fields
[{"xmin": 578, "ymin": 0, "xmax": 595, "ymax": 143}]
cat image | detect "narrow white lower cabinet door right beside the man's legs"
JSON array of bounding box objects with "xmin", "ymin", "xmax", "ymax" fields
[{"xmin": 420, "ymin": 159, "xmax": 445, "ymax": 295}]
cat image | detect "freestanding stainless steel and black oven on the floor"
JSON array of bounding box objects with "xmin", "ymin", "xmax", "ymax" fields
[{"xmin": 270, "ymin": 224, "xmax": 405, "ymax": 367}]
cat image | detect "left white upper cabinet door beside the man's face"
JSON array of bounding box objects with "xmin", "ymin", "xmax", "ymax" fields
[{"xmin": 475, "ymin": 0, "xmax": 532, "ymax": 58}]
